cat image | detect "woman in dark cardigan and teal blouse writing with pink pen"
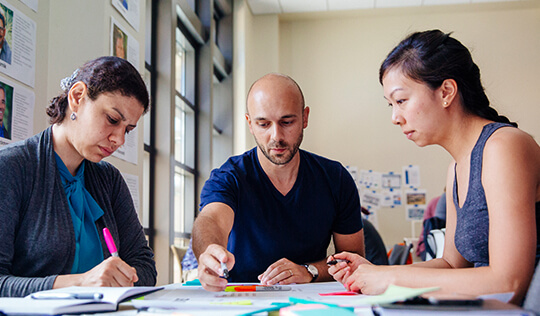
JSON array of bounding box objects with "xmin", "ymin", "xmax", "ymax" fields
[{"xmin": 0, "ymin": 57, "xmax": 157, "ymax": 296}]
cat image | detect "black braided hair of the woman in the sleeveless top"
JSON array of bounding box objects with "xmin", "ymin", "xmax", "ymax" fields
[{"xmin": 379, "ymin": 30, "xmax": 517, "ymax": 127}]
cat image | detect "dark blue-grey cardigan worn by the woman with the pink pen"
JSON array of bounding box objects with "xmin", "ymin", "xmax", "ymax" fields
[{"xmin": 0, "ymin": 126, "xmax": 157, "ymax": 297}]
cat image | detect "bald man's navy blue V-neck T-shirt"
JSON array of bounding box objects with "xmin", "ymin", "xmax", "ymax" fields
[{"xmin": 200, "ymin": 148, "xmax": 362, "ymax": 282}]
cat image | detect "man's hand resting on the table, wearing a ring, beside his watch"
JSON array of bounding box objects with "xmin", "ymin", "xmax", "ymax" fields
[{"xmin": 258, "ymin": 258, "xmax": 313, "ymax": 285}]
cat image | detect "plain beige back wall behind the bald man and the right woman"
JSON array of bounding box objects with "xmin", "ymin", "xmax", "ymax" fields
[{"xmin": 235, "ymin": 1, "xmax": 540, "ymax": 246}]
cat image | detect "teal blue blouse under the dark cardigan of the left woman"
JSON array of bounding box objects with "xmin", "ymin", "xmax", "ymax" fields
[{"xmin": 54, "ymin": 153, "xmax": 103, "ymax": 274}]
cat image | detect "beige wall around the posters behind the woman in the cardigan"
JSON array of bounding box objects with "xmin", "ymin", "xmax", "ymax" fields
[{"xmin": 0, "ymin": 0, "xmax": 145, "ymax": 209}]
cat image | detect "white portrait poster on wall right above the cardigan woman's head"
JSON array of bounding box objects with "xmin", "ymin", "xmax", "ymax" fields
[{"xmin": 110, "ymin": 17, "xmax": 139, "ymax": 69}]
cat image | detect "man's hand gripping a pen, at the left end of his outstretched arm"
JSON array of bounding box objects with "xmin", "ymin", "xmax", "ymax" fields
[{"xmin": 198, "ymin": 244, "xmax": 234, "ymax": 292}]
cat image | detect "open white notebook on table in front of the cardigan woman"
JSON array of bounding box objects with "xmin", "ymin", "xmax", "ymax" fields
[{"xmin": 0, "ymin": 286, "xmax": 162, "ymax": 315}]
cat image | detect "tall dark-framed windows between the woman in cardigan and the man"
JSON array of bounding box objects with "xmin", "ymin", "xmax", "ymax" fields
[{"xmin": 148, "ymin": 0, "xmax": 232, "ymax": 284}]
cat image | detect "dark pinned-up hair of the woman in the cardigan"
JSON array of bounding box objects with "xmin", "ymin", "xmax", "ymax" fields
[{"xmin": 47, "ymin": 56, "xmax": 150, "ymax": 124}]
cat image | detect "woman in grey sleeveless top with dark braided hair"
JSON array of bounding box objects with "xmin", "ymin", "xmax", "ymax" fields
[{"xmin": 329, "ymin": 30, "xmax": 540, "ymax": 304}]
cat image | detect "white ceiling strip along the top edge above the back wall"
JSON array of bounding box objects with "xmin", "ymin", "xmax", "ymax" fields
[{"xmin": 247, "ymin": 0, "xmax": 520, "ymax": 15}]
